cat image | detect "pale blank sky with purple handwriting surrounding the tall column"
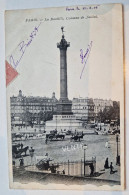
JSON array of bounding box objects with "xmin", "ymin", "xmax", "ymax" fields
[{"xmin": 5, "ymin": 5, "xmax": 123, "ymax": 101}]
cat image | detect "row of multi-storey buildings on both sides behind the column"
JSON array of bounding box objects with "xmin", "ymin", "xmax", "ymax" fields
[{"xmin": 10, "ymin": 90, "xmax": 113, "ymax": 125}]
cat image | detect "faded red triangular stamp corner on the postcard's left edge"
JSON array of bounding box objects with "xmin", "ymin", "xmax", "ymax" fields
[{"xmin": 5, "ymin": 61, "xmax": 18, "ymax": 86}]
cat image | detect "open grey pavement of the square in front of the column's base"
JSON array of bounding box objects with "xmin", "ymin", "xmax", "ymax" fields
[{"xmin": 14, "ymin": 134, "xmax": 120, "ymax": 182}]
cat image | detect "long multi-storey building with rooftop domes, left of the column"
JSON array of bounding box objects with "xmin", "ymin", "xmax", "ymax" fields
[{"xmin": 10, "ymin": 90, "xmax": 57, "ymax": 125}]
